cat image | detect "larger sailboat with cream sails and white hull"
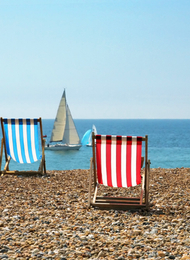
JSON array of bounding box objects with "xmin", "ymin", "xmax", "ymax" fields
[{"xmin": 45, "ymin": 90, "xmax": 81, "ymax": 151}]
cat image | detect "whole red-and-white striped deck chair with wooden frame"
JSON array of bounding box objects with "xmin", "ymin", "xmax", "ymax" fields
[{"xmin": 88, "ymin": 134, "xmax": 150, "ymax": 210}]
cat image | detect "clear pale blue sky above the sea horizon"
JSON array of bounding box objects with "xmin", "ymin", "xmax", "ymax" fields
[{"xmin": 0, "ymin": 0, "xmax": 190, "ymax": 119}]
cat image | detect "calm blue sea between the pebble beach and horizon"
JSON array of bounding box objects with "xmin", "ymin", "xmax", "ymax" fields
[{"xmin": 2, "ymin": 119, "xmax": 190, "ymax": 170}]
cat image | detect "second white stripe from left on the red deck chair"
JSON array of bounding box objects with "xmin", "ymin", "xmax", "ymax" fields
[{"xmin": 111, "ymin": 136, "xmax": 117, "ymax": 187}]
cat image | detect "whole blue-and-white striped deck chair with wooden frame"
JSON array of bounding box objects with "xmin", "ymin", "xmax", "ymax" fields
[{"xmin": 0, "ymin": 118, "xmax": 46, "ymax": 174}]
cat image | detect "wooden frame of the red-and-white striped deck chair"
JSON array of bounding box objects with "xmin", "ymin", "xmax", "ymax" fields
[{"xmin": 88, "ymin": 133, "xmax": 150, "ymax": 210}]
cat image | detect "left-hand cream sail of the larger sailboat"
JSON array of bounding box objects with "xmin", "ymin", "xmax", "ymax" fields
[{"xmin": 50, "ymin": 90, "xmax": 66, "ymax": 142}]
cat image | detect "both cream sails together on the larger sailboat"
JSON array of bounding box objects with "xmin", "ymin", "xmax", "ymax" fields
[{"xmin": 50, "ymin": 90, "xmax": 80, "ymax": 144}]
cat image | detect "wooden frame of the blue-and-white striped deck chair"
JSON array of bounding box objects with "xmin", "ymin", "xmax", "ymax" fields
[{"xmin": 0, "ymin": 117, "xmax": 46, "ymax": 175}]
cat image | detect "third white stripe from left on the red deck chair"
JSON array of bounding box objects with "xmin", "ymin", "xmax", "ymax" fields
[{"xmin": 121, "ymin": 136, "xmax": 127, "ymax": 187}]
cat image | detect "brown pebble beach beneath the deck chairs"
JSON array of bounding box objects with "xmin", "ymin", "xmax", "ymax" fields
[{"xmin": 0, "ymin": 168, "xmax": 190, "ymax": 260}]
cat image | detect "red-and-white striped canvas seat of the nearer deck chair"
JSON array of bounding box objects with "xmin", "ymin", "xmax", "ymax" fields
[{"xmin": 96, "ymin": 135, "xmax": 142, "ymax": 187}]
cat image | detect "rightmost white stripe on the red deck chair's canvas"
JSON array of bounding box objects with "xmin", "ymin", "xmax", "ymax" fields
[{"xmin": 131, "ymin": 136, "xmax": 137, "ymax": 186}]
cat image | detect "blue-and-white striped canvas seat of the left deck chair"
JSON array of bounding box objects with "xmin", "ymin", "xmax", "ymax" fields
[{"xmin": 4, "ymin": 119, "xmax": 42, "ymax": 163}]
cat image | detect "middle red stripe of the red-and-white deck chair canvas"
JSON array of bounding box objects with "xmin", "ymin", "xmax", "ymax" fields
[{"xmin": 116, "ymin": 136, "xmax": 122, "ymax": 187}]
